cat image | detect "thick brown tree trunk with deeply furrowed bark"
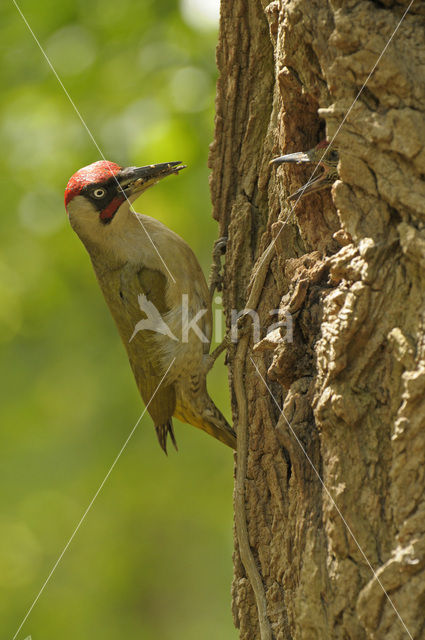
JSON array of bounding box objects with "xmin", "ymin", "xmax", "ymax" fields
[{"xmin": 210, "ymin": 0, "xmax": 425, "ymax": 640}]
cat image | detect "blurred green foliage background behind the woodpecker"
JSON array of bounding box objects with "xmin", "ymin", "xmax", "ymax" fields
[{"xmin": 0, "ymin": 0, "xmax": 236, "ymax": 640}]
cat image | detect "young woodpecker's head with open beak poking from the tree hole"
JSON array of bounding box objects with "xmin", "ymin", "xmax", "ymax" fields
[{"xmin": 270, "ymin": 140, "xmax": 339, "ymax": 200}]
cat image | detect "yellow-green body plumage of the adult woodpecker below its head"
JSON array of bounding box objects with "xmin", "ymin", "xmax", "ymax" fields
[{"xmin": 68, "ymin": 165, "xmax": 236, "ymax": 451}]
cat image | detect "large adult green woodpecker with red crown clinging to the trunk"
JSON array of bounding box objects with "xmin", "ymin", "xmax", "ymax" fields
[{"xmin": 65, "ymin": 161, "xmax": 236, "ymax": 452}]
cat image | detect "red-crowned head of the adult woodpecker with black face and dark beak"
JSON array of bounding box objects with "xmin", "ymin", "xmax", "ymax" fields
[{"xmin": 65, "ymin": 160, "xmax": 185, "ymax": 235}]
